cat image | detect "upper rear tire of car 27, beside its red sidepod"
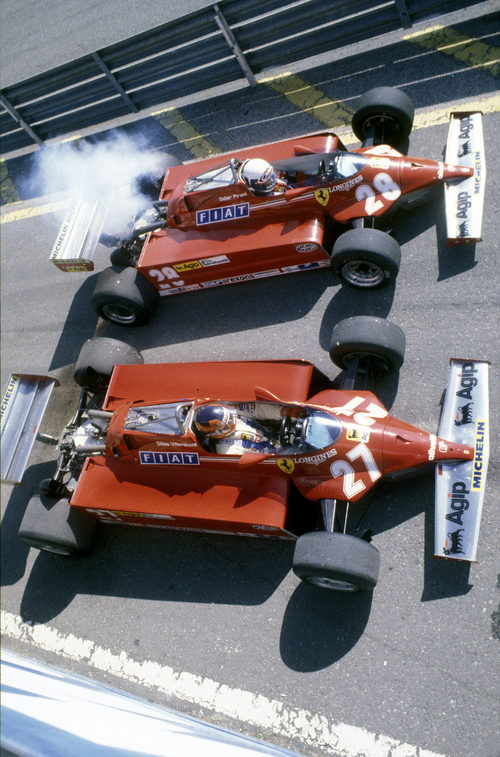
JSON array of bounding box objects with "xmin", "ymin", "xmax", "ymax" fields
[{"xmin": 73, "ymin": 337, "xmax": 144, "ymax": 394}]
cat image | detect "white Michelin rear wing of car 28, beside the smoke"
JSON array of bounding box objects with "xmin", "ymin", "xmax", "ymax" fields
[{"xmin": 49, "ymin": 192, "xmax": 114, "ymax": 272}]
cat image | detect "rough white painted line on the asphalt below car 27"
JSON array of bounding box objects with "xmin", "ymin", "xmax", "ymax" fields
[{"xmin": 1, "ymin": 610, "xmax": 444, "ymax": 757}]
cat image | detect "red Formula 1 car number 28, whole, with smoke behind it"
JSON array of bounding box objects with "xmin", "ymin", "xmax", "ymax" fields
[{"xmin": 51, "ymin": 87, "xmax": 485, "ymax": 325}]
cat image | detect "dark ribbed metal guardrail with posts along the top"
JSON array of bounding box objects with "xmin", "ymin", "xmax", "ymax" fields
[{"xmin": 0, "ymin": 0, "xmax": 480, "ymax": 154}]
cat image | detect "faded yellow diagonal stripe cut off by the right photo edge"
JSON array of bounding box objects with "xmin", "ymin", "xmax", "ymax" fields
[{"xmin": 403, "ymin": 24, "xmax": 500, "ymax": 79}]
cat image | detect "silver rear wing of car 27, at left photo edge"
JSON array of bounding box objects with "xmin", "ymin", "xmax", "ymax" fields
[{"xmin": 0, "ymin": 373, "xmax": 59, "ymax": 484}]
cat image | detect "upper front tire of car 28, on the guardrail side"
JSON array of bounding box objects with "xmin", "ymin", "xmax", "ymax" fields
[{"xmin": 351, "ymin": 87, "xmax": 415, "ymax": 147}]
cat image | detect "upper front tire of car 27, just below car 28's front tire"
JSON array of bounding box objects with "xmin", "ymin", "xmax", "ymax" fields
[{"xmin": 330, "ymin": 315, "xmax": 406, "ymax": 374}]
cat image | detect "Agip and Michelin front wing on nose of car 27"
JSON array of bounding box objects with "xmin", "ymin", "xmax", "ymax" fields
[{"xmin": 434, "ymin": 359, "xmax": 489, "ymax": 561}]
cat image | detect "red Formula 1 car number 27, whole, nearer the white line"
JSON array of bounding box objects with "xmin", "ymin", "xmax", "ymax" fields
[{"xmin": 2, "ymin": 317, "xmax": 488, "ymax": 590}]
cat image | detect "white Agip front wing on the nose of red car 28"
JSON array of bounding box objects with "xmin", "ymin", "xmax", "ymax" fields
[{"xmin": 444, "ymin": 111, "xmax": 486, "ymax": 246}]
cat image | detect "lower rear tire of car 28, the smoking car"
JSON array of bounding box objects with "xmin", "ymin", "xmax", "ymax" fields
[{"xmin": 92, "ymin": 268, "xmax": 158, "ymax": 326}]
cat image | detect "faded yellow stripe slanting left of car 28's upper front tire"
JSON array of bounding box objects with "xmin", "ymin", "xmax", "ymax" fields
[{"xmin": 259, "ymin": 73, "xmax": 354, "ymax": 129}]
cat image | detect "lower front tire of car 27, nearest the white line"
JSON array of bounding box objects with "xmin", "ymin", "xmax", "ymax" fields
[{"xmin": 293, "ymin": 531, "xmax": 380, "ymax": 592}]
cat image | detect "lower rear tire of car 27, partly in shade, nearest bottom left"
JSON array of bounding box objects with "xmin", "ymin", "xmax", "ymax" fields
[{"xmin": 19, "ymin": 494, "xmax": 96, "ymax": 556}]
